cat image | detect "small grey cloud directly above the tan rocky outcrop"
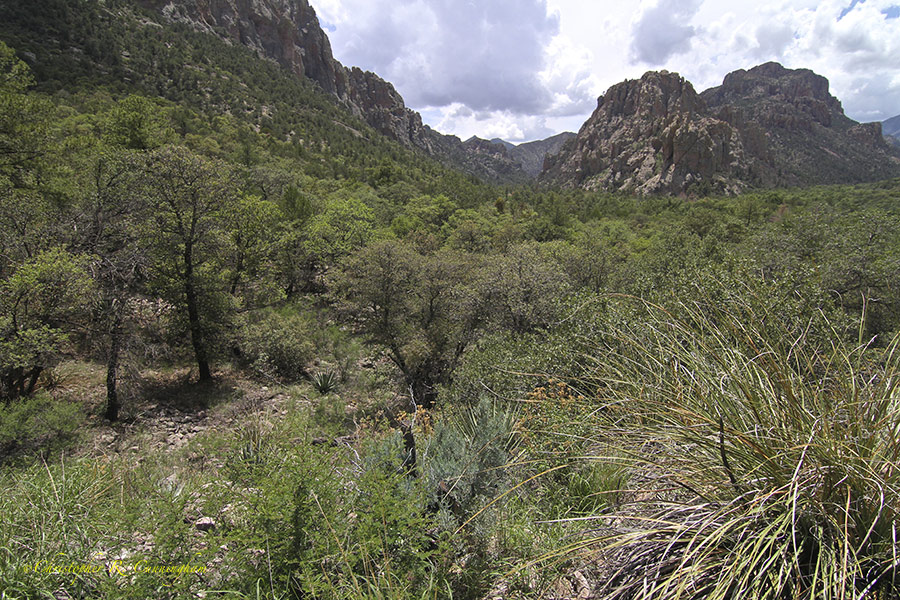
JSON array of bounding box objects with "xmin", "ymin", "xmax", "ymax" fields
[{"xmin": 631, "ymin": 0, "xmax": 702, "ymax": 66}]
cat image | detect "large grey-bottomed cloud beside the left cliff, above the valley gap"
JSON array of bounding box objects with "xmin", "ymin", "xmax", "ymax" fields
[{"xmin": 321, "ymin": 0, "xmax": 576, "ymax": 114}]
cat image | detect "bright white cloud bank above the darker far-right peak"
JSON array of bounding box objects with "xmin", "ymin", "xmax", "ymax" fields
[{"xmin": 656, "ymin": 0, "xmax": 900, "ymax": 121}]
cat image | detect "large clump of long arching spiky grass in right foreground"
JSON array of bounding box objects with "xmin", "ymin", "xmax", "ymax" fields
[{"xmin": 587, "ymin": 294, "xmax": 900, "ymax": 600}]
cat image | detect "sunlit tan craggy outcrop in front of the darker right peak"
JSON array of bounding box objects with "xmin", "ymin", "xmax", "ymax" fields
[{"xmin": 542, "ymin": 71, "xmax": 748, "ymax": 194}]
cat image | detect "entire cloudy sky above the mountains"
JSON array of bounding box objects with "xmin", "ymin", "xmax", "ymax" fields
[{"xmin": 311, "ymin": 0, "xmax": 900, "ymax": 143}]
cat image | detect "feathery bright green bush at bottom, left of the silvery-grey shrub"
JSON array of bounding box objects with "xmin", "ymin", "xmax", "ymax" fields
[{"xmin": 293, "ymin": 436, "xmax": 442, "ymax": 598}]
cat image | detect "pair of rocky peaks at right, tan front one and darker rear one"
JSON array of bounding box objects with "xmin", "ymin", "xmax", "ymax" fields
[{"xmin": 541, "ymin": 63, "xmax": 900, "ymax": 194}]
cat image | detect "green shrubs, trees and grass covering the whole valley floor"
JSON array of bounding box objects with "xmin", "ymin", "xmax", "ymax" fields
[{"xmin": 0, "ymin": 28, "xmax": 900, "ymax": 598}]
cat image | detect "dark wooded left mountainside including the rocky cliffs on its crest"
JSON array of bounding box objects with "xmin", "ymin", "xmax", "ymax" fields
[{"xmin": 0, "ymin": 0, "xmax": 527, "ymax": 182}]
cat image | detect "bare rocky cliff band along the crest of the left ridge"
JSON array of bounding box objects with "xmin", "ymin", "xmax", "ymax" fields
[{"xmin": 137, "ymin": 0, "xmax": 527, "ymax": 181}]
